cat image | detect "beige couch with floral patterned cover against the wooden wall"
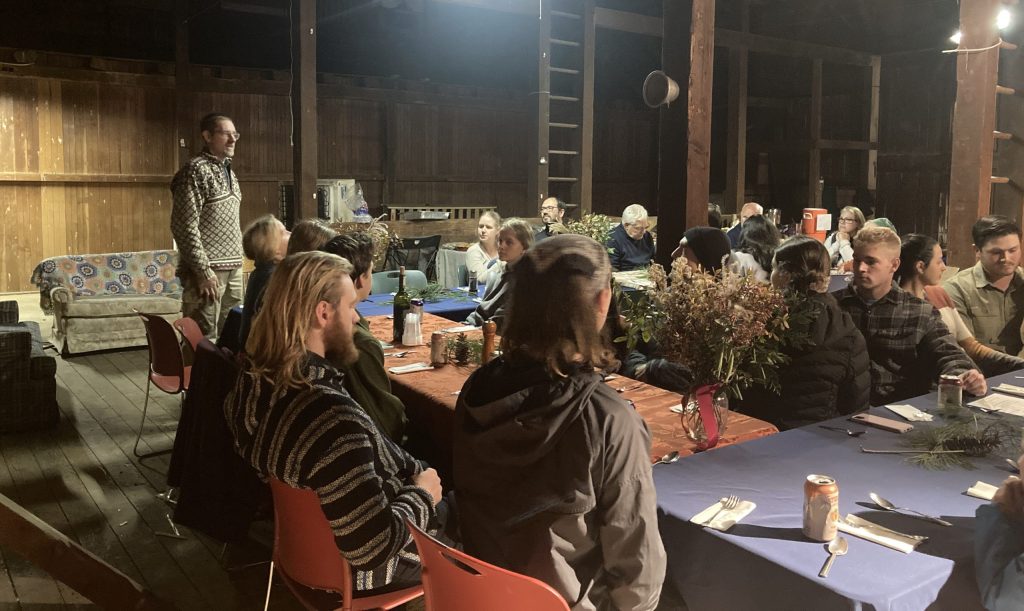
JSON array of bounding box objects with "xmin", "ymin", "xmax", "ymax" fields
[{"xmin": 32, "ymin": 251, "xmax": 181, "ymax": 354}]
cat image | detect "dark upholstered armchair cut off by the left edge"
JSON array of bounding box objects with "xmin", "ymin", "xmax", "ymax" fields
[{"xmin": 0, "ymin": 301, "xmax": 59, "ymax": 433}]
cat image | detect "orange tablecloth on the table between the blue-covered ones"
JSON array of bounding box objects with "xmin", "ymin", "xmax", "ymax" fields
[{"xmin": 368, "ymin": 314, "xmax": 778, "ymax": 468}]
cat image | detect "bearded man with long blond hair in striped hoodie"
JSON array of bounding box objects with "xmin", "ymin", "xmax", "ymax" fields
[{"xmin": 224, "ymin": 252, "xmax": 444, "ymax": 594}]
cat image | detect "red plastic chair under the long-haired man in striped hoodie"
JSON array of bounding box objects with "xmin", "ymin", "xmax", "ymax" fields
[{"xmin": 263, "ymin": 478, "xmax": 423, "ymax": 611}]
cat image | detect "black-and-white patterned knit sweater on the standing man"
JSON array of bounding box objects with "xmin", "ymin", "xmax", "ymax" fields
[{"xmin": 171, "ymin": 152, "xmax": 242, "ymax": 280}]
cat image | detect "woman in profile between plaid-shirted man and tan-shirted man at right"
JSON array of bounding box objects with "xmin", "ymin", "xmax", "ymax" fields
[{"xmin": 895, "ymin": 233, "xmax": 1024, "ymax": 376}]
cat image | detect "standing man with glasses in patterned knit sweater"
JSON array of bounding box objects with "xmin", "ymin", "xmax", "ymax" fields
[{"xmin": 171, "ymin": 113, "xmax": 242, "ymax": 340}]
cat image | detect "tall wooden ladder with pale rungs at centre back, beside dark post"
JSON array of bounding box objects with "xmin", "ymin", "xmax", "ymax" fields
[{"xmin": 528, "ymin": 0, "xmax": 594, "ymax": 212}]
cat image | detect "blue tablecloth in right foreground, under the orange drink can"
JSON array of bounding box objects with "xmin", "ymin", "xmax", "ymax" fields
[{"xmin": 654, "ymin": 368, "xmax": 1024, "ymax": 611}]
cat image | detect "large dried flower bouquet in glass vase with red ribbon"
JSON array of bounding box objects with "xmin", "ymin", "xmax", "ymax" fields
[{"xmin": 621, "ymin": 258, "xmax": 794, "ymax": 448}]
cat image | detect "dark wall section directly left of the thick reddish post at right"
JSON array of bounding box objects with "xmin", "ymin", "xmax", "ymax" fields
[{"xmin": 876, "ymin": 51, "xmax": 954, "ymax": 245}]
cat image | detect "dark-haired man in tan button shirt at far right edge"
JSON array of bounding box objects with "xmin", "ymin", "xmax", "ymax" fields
[{"xmin": 944, "ymin": 215, "xmax": 1024, "ymax": 356}]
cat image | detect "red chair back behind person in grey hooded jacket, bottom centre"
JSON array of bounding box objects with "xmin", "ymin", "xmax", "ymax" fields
[{"xmin": 406, "ymin": 520, "xmax": 569, "ymax": 611}]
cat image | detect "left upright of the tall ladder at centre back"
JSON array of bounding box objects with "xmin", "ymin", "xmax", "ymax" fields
[{"xmin": 525, "ymin": 1, "xmax": 551, "ymax": 216}]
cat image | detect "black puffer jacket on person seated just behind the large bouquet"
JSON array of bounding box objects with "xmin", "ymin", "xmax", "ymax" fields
[{"xmin": 733, "ymin": 294, "xmax": 871, "ymax": 430}]
